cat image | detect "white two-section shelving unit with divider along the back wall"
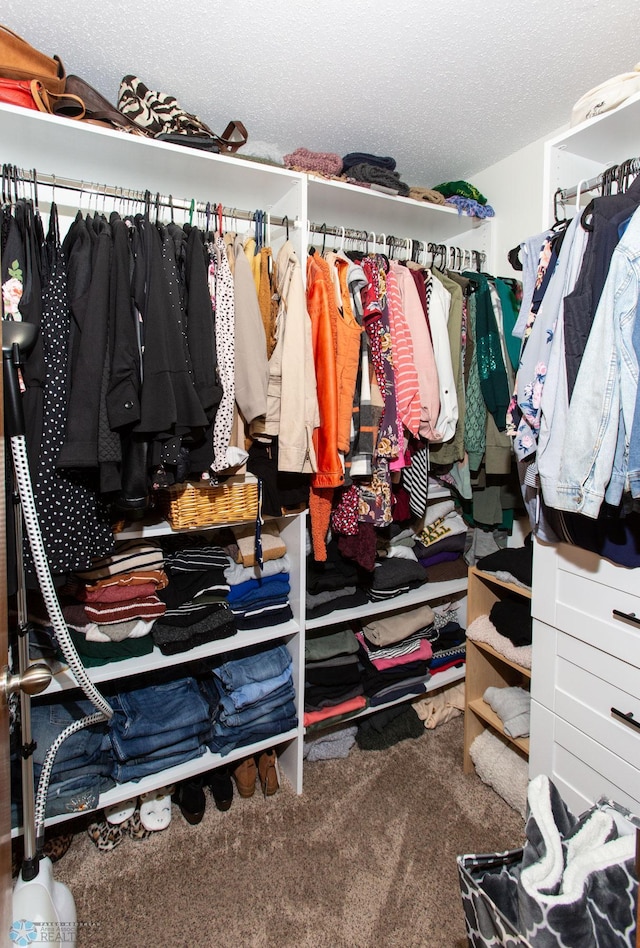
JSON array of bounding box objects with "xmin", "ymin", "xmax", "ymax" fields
[{"xmin": 0, "ymin": 105, "xmax": 491, "ymax": 832}]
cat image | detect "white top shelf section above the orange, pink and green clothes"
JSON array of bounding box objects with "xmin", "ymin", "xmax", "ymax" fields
[{"xmin": 308, "ymin": 175, "xmax": 488, "ymax": 243}]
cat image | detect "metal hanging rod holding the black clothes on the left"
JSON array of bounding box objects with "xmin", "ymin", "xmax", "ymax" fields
[{"xmin": 3, "ymin": 166, "xmax": 300, "ymax": 229}]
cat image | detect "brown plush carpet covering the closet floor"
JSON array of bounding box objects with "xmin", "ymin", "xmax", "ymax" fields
[{"xmin": 46, "ymin": 717, "xmax": 524, "ymax": 948}]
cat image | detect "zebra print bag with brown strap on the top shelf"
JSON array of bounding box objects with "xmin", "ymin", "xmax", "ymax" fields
[{"xmin": 118, "ymin": 76, "xmax": 248, "ymax": 153}]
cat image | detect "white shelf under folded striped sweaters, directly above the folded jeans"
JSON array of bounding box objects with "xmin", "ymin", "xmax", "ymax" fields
[{"xmin": 43, "ymin": 619, "xmax": 300, "ymax": 696}]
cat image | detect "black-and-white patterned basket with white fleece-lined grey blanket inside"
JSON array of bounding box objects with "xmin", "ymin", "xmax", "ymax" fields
[{"xmin": 457, "ymin": 776, "xmax": 640, "ymax": 948}]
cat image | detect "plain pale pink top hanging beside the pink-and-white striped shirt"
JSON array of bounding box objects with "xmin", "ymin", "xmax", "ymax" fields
[{"xmin": 390, "ymin": 260, "xmax": 442, "ymax": 441}]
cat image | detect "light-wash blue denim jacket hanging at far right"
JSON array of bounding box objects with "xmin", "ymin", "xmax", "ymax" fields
[{"xmin": 555, "ymin": 203, "xmax": 640, "ymax": 518}]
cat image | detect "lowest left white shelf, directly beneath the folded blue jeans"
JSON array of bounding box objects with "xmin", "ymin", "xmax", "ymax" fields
[{"xmin": 11, "ymin": 728, "xmax": 298, "ymax": 837}]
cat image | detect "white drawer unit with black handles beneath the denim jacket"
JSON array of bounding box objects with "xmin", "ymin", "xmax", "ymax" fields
[{"xmin": 529, "ymin": 544, "xmax": 640, "ymax": 814}]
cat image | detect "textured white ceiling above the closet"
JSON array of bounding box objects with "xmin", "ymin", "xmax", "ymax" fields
[{"xmin": 1, "ymin": 0, "xmax": 640, "ymax": 186}]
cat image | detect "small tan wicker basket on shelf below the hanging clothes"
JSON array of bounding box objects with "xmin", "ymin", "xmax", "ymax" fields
[{"xmin": 157, "ymin": 480, "xmax": 258, "ymax": 530}]
